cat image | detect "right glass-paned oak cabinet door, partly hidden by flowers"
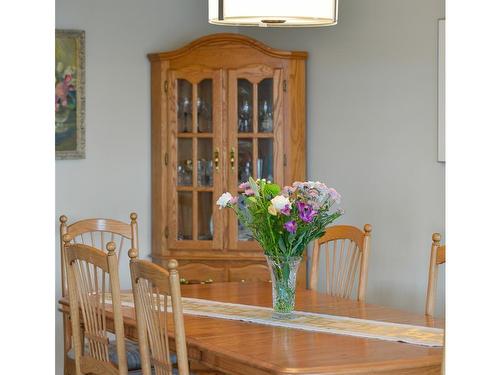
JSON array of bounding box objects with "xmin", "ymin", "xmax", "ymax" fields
[{"xmin": 228, "ymin": 65, "xmax": 283, "ymax": 250}]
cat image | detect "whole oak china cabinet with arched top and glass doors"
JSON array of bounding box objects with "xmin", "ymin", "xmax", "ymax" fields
[{"xmin": 148, "ymin": 34, "xmax": 307, "ymax": 285}]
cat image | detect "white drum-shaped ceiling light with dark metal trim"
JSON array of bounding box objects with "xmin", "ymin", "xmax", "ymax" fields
[{"xmin": 208, "ymin": 0, "xmax": 338, "ymax": 27}]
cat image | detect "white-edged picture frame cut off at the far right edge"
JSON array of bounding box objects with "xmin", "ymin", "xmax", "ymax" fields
[{"xmin": 438, "ymin": 19, "xmax": 446, "ymax": 163}]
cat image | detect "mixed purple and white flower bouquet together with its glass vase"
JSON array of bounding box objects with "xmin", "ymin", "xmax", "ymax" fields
[{"xmin": 217, "ymin": 178, "xmax": 343, "ymax": 318}]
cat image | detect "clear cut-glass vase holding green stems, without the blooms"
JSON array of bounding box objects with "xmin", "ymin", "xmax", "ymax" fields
[{"xmin": 266, "ymin": 255, "xmax": 302, "ymax": 319}]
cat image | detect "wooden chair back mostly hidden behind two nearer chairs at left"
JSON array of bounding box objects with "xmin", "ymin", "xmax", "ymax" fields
[{"xmin": 59, "ymin": 212, "xmax": 138, "ymax": 297}]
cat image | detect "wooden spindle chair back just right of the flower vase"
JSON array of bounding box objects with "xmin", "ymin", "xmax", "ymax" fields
[{"xmin": 309, "ymin": 224, "xmax": 372, "ymax": 301}]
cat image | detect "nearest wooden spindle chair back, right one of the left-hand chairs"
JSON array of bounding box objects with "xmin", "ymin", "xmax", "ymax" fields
[{"xmin": 129, "ymin": 249, "xmax": 189, "ymax": 375}]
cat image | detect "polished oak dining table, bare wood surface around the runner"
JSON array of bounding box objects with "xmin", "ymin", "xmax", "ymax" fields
[{"xmin": 60, "ymin": 282, "xmax": 444, "ymax": 375}]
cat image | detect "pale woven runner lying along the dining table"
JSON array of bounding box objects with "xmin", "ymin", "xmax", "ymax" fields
[{"xmin": 106, "ymin": 293, "xmax": 444, "ymax": 347}]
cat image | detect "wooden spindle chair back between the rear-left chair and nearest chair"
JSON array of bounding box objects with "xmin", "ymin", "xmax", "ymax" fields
[{"xmin": 63, "ymin": 239, "xmax": 128, "ymax": 375}]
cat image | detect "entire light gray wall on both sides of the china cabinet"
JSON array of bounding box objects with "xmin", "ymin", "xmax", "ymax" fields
[{"xmin": 54, "ymin": 0, "xmax": 444, "ymax": 373}]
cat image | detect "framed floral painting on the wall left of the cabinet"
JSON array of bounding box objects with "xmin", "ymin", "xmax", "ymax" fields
[{"xmin": 55, "ymin": 30, "xmax": 85, "ymax": 159}]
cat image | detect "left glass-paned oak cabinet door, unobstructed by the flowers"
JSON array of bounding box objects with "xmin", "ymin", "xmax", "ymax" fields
[{"xmin": 168, "ymin": 70, "xmax": 222, "ymax": 249}]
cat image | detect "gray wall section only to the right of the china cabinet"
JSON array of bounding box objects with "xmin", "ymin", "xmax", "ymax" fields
[{"xmin": 240, "ymin": 0, "xmax": 445, "ymax": 315}]
